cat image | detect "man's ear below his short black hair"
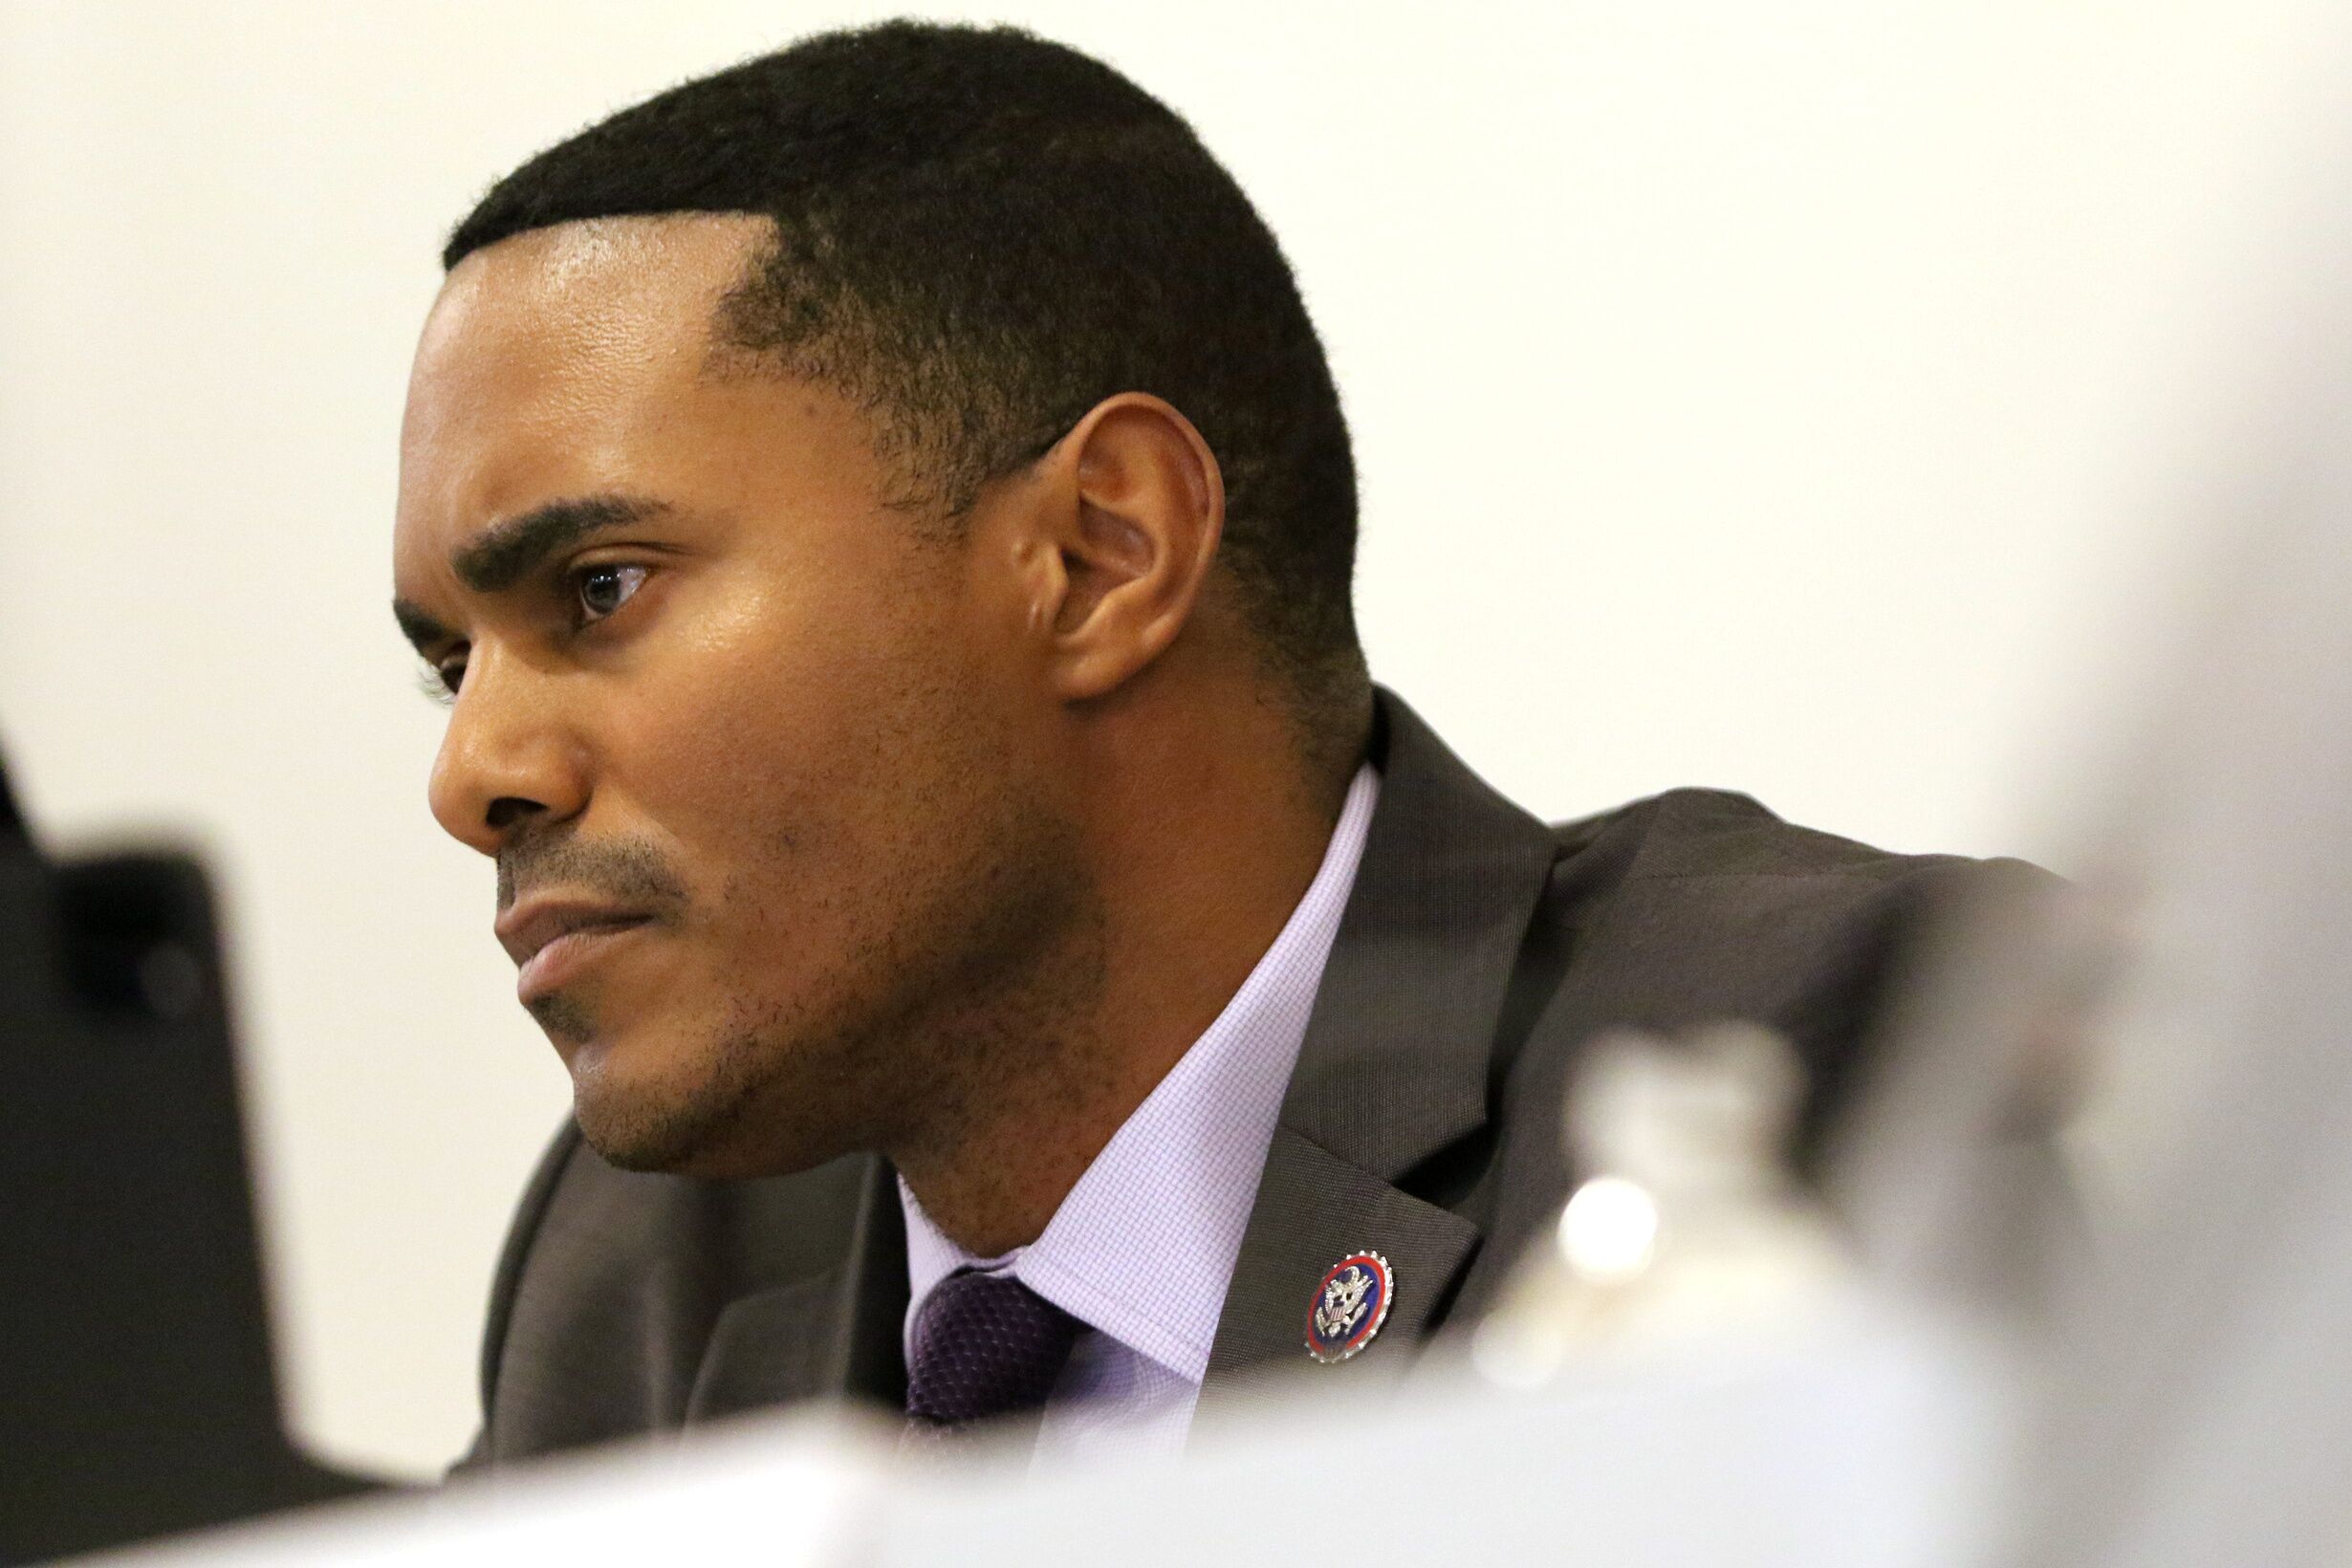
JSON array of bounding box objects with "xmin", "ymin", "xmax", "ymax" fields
[{"xmin": 1033, "ymin": 393, "xmax": 1226, "ymax": 701}]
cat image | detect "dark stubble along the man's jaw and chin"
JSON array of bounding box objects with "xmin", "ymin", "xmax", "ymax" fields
[{"xmin": 557, "ymin": 733, "xmax": 1105, "ymax": 1178}]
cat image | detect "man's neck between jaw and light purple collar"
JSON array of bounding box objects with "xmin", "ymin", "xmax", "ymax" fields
[{"xmin": 884, "ymin": 672, "xmax": 1353, "ymax": 1257}]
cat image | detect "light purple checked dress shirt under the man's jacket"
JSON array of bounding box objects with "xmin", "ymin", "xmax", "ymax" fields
[{"xmin": 899, "ymin": 764, "xmax": 1381, "ymax": 1460}]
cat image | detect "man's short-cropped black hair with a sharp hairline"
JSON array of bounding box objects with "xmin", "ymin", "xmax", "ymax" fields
[{"xmin": 442, "ymin": 21, "xmax": 1366, "ymax": 741}]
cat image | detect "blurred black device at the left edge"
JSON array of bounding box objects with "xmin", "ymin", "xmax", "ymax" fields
[{"xmin": 0, "ymin": 773, "xmax": 359, "ymax": 1563}]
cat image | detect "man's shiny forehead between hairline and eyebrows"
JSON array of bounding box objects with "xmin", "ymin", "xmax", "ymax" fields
[{"xmin": 395, "ymin": 214, "xmax": 767, "ymax": 571}]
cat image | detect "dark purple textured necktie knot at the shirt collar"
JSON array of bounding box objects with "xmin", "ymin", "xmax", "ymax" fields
[{"xmin": 905, "ymin": 1270, "xmax": 1084, "ymax": 1429}]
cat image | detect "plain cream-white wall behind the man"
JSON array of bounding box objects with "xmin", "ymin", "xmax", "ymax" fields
[{"xmin": 0, "ymin": 0, "xmax": 2352, "ymax": 1474}]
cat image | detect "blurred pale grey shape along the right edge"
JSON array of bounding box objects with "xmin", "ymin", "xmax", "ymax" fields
[{"xmin": 2015, "ymin": 364, "xmax": 2352, "ymax": 1568}]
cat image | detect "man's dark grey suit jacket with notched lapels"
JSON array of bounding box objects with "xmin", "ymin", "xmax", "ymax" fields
[{"xmin": 464, "ymin": 691, "xmax": 2039, "ymax": 1467}]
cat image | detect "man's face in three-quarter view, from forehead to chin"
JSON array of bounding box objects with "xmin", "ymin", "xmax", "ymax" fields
[{"xmin": 393, "ymin": 216, "xmax": 1084, "ymax": 1175}]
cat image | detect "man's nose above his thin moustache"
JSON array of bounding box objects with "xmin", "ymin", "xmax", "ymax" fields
[{"xmin": 428, "ymin": 646, "xmax": 588, "ymax": 856}]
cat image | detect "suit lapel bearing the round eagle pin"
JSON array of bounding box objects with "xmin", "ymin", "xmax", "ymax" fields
[{"xmin": 1209, "ymin": 691, "xmax": 1557, "ymax": 1380}]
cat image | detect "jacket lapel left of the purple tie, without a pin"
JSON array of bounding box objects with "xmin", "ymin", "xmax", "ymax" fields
[{"xmin": 686, "ymin": 1159, "xmax": 908, "ymax": 1423}]
